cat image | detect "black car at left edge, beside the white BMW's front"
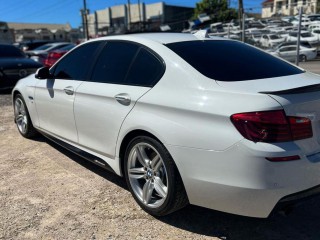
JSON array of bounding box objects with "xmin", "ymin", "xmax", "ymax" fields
[{"xmin": 0, "ymin": 44, "xmax": 42, "ymax": 89}]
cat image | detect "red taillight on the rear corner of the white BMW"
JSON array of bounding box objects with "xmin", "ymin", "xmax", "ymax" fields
[{"xmin": 231, "ymin": 110, "xmax": 313, "ymax": 143}]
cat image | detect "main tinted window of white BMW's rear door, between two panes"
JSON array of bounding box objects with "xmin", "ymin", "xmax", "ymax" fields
[{"xmin": 91, "ymin": 41, "xmax": 139, "ymax": 84}]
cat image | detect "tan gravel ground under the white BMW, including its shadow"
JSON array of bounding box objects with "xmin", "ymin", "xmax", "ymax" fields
[{"xmin": 0, "ymin": 62, "xmax": 320, "ymax": 240}]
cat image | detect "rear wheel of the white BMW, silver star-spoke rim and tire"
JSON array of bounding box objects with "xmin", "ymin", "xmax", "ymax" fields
[{"xmin": 124, "ymin": 136, "xmax": 189, "ymax": 216}]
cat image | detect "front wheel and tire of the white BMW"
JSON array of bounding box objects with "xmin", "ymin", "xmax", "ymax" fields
[{"xmin": 13, "ymin": 94, "xmax": 38, "ymax": 139}]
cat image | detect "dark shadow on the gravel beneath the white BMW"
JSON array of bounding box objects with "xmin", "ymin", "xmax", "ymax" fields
[{"xmin": 44, "ymin": 139, "xmax": 320, "ymax": 240}]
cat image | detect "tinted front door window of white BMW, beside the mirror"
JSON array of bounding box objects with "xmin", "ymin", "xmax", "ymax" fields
[{"xmin": 53, "ymin": 42, "xmax": 101, "ymax": 80}]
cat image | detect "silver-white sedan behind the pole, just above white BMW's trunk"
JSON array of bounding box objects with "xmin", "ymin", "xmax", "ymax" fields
[{"xmin": 270, "ymin": 45, "xmax": 317, "ymax": 62}]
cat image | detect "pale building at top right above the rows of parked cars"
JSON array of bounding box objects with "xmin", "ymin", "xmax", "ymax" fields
[{"xmin": 262, "ymin": 0, "xmax": 317, "ymax": 18}]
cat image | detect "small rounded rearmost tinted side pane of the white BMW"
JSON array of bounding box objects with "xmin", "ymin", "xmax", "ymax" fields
[{"xmin": 126, "ymin": 48, "xmax": 164, "ymax": 87}]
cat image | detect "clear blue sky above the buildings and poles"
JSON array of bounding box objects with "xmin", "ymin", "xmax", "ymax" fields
[{"xmin": 0, "ymin": 0, "xmax": 262, "ymax": 27}]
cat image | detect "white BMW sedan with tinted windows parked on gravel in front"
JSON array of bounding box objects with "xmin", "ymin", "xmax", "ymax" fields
[{"xmin": 12, "ymin": 33, "xmax": 320, "ymax": 217}]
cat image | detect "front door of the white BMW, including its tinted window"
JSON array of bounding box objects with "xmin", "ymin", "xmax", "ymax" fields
[{"xmin": 35, "ymin": 42, "xmax": 101, "ymax": 142}]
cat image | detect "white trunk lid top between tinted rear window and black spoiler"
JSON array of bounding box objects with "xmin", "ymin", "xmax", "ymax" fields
[{"xmin": 216, "ymin": 72, "xmax": 320, "ymax": 93}]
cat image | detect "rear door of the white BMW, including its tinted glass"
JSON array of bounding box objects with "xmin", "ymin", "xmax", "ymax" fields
[{"xmin": 74, "ymin": 41, "xmax": 164, "ymax": 158}]
